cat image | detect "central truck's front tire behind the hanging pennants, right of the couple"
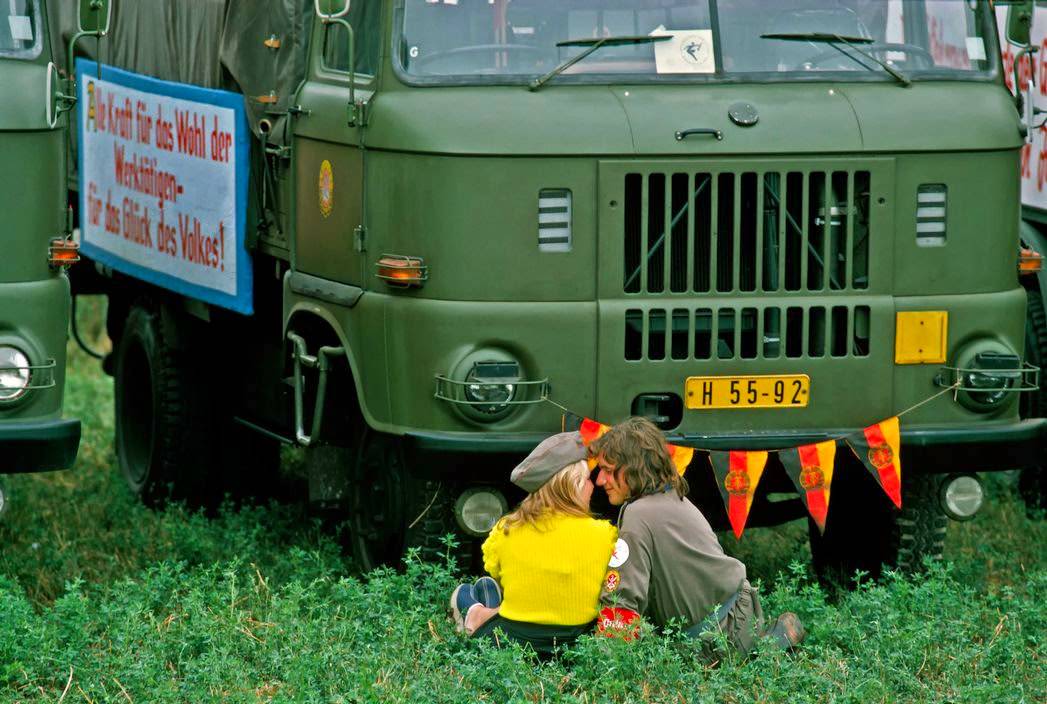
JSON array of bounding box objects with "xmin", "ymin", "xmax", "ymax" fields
[{"xmin": 808, "ymin": 457, "xmax": 948, "ymax": 588}]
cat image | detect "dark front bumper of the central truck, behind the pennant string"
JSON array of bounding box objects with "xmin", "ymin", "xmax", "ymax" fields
[{"xmin": 404, "ymin": 418, "xmax": 1047, "ymax": 472}]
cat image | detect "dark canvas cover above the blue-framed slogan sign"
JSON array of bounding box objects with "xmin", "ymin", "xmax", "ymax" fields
[{"xmin": 48, "ymin": 0, "xmax": 313, "ymax": 133}]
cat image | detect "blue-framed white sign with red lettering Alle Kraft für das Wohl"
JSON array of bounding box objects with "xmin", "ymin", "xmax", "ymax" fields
[{"xmin": 80, "ymin": 60, "xmax": 251, "ymax": 312}]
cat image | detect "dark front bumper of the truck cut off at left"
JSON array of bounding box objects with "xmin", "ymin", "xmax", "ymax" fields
[{"xmin": 0, "ymin": 419, "xmax": 81, "ymax": 475}]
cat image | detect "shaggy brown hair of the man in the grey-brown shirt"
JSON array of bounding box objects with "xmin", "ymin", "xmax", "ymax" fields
[{"xmin": 589, "ymin": 417, "xmax": 688, "ymax": 499}]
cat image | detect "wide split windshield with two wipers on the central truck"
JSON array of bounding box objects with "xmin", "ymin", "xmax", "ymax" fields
[{"xmin": 399, "ymin": 0, "xmax": 998, "ymax": 83}]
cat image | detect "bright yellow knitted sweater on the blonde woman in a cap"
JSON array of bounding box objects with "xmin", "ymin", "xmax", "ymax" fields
[{"xmin": 484, "ymin": 514, "xmax": 618, "ymax": 625}]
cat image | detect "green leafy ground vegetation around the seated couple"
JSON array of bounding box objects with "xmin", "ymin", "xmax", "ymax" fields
[{"xmin": 0, "ymin": 297, "xmax": 1047, "ymax": 704}]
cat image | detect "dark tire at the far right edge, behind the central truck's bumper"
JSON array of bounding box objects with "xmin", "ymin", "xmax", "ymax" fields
[{"xmin": 1018, "ymin": 288, "xmax": 1047, "ymax": 518}]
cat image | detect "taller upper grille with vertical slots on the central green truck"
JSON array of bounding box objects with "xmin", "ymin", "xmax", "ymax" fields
[{"xmin": 623, "ymin": 170, "xmax": 872, "ymax": 294}]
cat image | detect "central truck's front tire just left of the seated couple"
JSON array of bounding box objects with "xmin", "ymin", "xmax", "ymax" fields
[{"xmin": 349, "ymin": 430, "xmax": 474, "ymax": 572}]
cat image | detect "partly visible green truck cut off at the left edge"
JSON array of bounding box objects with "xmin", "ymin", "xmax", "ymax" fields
[{"xmin": 0, "ymin": 0, "xmax": 91, "ymax": 508}]
